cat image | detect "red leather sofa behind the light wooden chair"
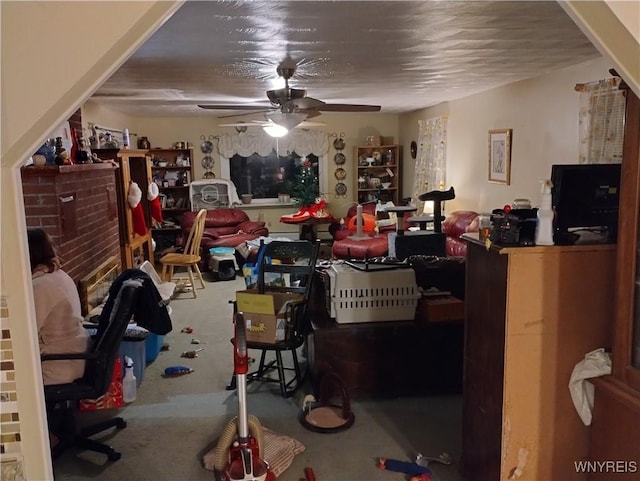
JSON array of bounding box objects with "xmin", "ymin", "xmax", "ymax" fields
[{"xmin": 181, "ymin": 209, "xmax": 269, "ymax": 269}]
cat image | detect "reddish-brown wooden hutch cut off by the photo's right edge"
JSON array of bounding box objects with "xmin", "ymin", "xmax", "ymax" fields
[{"xmin": 588, "ymin": 81, "xmax": 640, "ymax": 481}]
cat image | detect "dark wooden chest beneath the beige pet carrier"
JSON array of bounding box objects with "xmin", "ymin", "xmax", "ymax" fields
[{"xmin": 307, "ymin": 279, "xmax": 463, "ymax": 398}]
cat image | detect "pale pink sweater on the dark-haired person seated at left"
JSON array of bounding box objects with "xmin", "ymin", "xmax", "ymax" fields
[{"xmin": 33, "ymin": 269, "xmax": 90, "ymax": 385}]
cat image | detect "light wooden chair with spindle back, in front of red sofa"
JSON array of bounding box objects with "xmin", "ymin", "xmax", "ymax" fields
[{"xmin": 160, "ymin": 209, "xmax": 207, "ymax": 299}]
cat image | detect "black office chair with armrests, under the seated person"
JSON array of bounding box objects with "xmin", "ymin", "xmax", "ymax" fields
[{"xmin": 41, "ymin": 280, "xmax": 142, "ymax": 461}]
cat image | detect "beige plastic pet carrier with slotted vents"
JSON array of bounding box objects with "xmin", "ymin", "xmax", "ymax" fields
[{"xmin": 325, "ymin": 264, "xmax": 421, "ymax": 324}]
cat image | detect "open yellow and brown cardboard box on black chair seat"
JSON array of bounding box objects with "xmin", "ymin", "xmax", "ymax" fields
[{"xmin": 236, "ymin": 289, "xmax": 302, "ymax": 344}]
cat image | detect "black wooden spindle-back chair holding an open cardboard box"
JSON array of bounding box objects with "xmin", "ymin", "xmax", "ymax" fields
[{"xmin": 227, "ymin": 240, "xmax": 320, "ymax": 397}]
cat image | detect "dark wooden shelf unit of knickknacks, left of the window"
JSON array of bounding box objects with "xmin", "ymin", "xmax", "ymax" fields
[{"xmin": 149, "ymin": 149, "xmax": 193, "ymax": 225}]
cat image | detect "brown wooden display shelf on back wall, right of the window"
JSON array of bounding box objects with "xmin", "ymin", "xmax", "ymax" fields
[{"xmin": 354, "ymin": 145, "xmax": 402, "ymax": 205}]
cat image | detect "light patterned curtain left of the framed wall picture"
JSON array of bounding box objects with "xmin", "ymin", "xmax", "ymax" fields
[{"xmin": 411, "ymin": 116, "xmax": 447, "ymax": 213}]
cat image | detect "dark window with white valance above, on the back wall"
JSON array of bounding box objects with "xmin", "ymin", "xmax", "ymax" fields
[{"xmin": 229, "ymin": 150, "xmax": 319, "ymax": 200}]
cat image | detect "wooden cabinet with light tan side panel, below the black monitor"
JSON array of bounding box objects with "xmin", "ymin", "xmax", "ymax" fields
[{"xmin": 462, "ymin": 234, "xmax": 616, "ymax": 481}]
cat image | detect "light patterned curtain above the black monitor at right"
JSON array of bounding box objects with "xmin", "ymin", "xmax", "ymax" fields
[{"xmin": 576, "ymin": 78, "xmax": 625, "ymax": 164}]
